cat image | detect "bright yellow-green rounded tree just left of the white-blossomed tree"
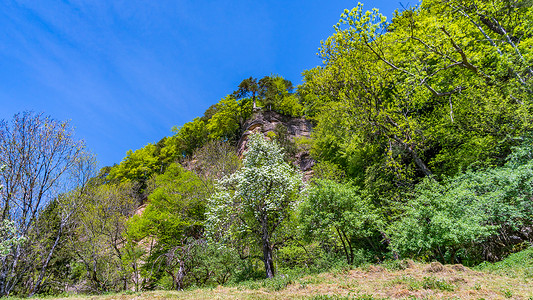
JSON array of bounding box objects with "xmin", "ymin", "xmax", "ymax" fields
[{"xmin": 127, "ymin": 163, "xmax": 211, "ymax": 289}]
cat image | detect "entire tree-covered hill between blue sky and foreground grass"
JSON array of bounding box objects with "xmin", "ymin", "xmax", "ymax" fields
[{"xmin": 0, "ymin": 0, "xmax": 533, "ymax": 296}]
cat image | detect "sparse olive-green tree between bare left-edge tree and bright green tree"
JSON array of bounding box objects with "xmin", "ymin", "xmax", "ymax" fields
[{"xmin": 68, "ymin": 182, "xmax": 138, "ymax": 292}]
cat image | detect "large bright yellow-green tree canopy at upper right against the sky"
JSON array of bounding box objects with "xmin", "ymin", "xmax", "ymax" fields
[{"xmin": 300, "ymin": 1, "xmax": 532, "ymax": 187}]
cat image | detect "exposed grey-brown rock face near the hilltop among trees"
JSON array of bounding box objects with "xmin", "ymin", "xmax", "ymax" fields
[{"xmin": 237, "ymin": 110, "xmax": 315, "ymax": 179}]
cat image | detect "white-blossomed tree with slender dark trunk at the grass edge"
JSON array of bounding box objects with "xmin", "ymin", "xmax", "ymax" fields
[{"xmin": 206, "ymin": 134, "xmax": 303, "ymax": 278}]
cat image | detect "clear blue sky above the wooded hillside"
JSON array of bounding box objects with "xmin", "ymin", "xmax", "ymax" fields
[{"xmin": 0, "ymin": 0, "xmax": 400, "ymax": 166}]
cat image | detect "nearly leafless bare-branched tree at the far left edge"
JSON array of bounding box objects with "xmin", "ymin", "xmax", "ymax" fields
[{"xmin": 0, "ymin": 112, "xmax": 93, "ymax": 296}]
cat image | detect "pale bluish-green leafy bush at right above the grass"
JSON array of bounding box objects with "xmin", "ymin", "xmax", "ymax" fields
[{"xmin": 390, "ymin": 142, "xmax": 533, "ymax": 262}]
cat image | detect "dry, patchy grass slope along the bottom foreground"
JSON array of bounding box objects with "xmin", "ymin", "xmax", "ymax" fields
[{"xmin": 22, "ymin": 253, "xmax": 533, "ymax": 300}]
